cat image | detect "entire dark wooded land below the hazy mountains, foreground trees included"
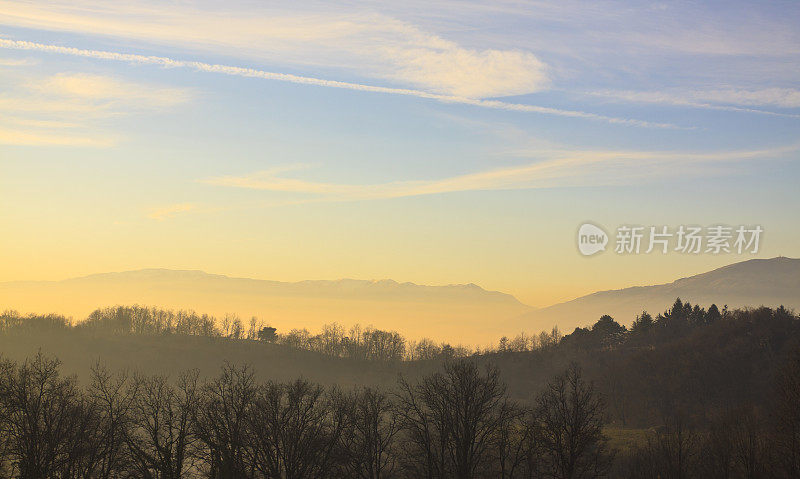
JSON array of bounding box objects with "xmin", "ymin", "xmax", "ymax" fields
[{"xmin": 0, "ymin": 300, "xmax": 800, "ymax": 478}]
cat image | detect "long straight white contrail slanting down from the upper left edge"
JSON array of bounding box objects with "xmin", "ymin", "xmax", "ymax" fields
[{"xmin": 0, "ymin": 38, "xmax": 680, "ymax": 129}]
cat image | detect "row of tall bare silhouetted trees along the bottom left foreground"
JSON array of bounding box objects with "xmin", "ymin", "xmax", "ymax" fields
[{"xmin": 0, "ymin": 354, "xmax": 611, "ymax": 479}]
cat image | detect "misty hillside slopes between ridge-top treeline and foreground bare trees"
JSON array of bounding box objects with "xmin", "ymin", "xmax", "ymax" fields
[{"xmin": 0, "ymin": 306, "xmax": 800, "ymax": 427}]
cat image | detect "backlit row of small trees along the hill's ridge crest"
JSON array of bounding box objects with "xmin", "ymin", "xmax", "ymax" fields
[{"xmin": 0, "ymin": 298, "xmax": 798, "ymax": 361}]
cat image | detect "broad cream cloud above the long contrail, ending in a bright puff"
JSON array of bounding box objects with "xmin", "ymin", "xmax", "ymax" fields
[{"xmin": 0, "ymin": 0, "xmax": 549, "ymax": 98}]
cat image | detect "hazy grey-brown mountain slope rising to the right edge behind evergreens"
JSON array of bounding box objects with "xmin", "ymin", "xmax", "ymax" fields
[{"xmin": 509, "ymin": 257, "xmax": 800, "ymax": 332}]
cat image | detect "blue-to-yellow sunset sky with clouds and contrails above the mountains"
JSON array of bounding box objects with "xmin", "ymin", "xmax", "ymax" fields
[{"xmin": 0, "ymin": 0, "xmax": 800, "ymax": 306}]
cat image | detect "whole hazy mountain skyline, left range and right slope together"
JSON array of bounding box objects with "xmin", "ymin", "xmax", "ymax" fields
[{"xmin": 0, "ymin": 257, "xmax": 800, "ymax": 344}]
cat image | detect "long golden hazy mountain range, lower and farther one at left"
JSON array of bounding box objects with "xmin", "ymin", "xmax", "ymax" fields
[{"xmin": 0, "ymin": 269, "xmax": 531, "ymax": 344}]
